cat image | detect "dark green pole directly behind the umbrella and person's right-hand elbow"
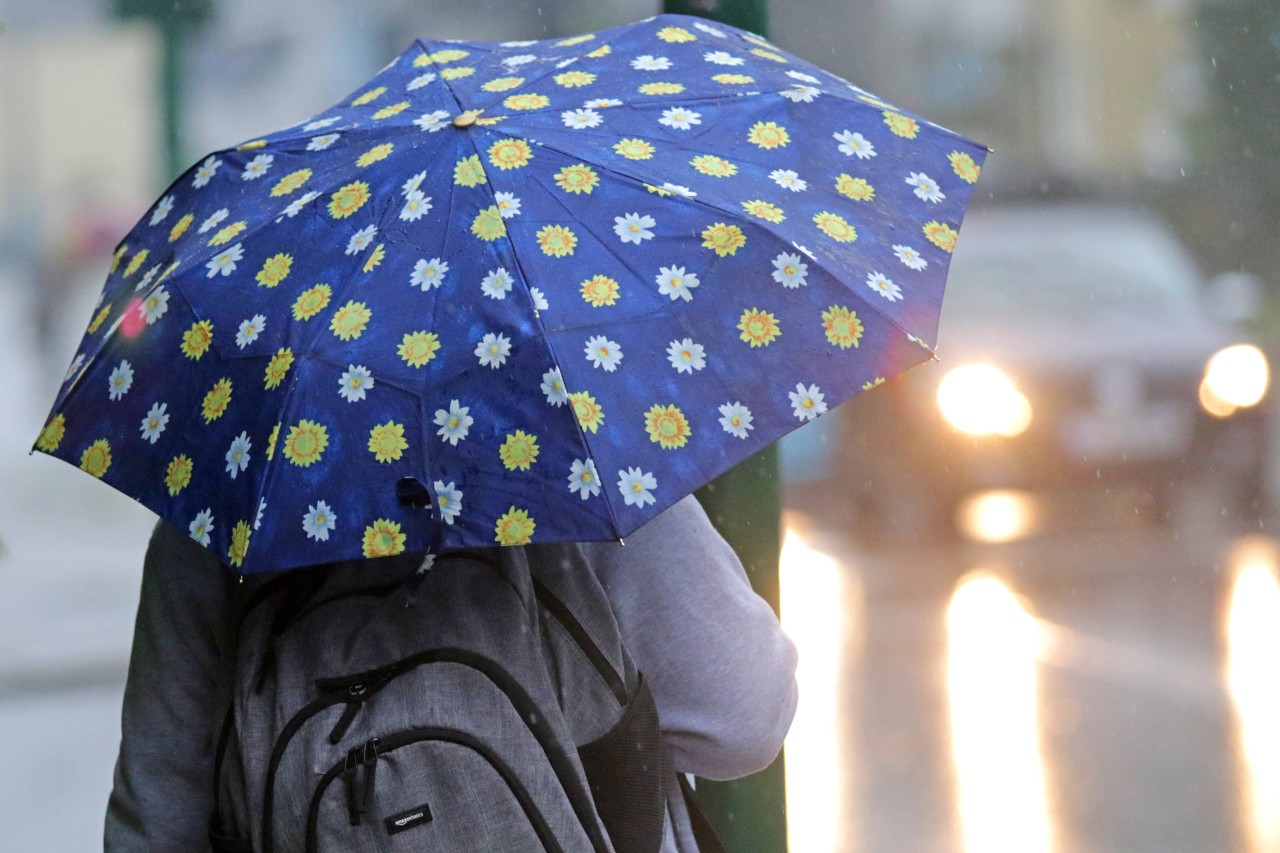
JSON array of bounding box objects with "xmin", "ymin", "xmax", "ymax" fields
[{"xmin": 663, "ymin": 6, "xmax": 787, "ymax": 853}]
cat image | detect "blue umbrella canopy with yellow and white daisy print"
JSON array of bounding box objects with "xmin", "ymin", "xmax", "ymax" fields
[{"xmin": 36, "ymin": 15, "xmax": 986, "ymax": 573}]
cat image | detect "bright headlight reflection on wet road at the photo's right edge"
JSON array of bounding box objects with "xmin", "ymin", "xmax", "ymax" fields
[{"xmin": 1226, "ymin": 539, "xmax": 1280, "ymax": 853}]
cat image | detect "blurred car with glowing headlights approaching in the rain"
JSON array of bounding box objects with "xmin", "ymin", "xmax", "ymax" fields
[{"xmin": 783, "ymin": 202, "xmax": 1270, "ymax": 542}]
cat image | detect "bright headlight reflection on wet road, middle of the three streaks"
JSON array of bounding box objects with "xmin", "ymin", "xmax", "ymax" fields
[{"xmin": 947, "ymin": 574, "xmax": 1053, "ymax": 853}]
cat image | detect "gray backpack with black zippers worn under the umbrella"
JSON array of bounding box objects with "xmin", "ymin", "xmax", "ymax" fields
[{"xmin": 210, "ymin": 544, "xmax": 673, "ymax": 853}]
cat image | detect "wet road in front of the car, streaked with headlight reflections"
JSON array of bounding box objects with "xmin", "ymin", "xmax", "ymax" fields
[{"xmin": 783, "ymin": 504, "xmax": 1280, "ymax": 853}]
